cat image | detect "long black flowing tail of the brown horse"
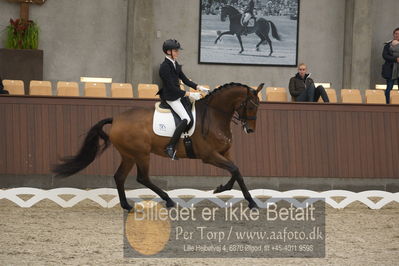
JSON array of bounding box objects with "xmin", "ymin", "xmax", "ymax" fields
[{"xmin": 52, "ymin": 118, "xmax": 113, "ymax": 177}]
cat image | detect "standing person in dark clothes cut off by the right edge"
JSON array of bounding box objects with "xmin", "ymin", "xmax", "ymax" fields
[{"xmin": 382, "ymin": 28, "xmax": 399, "ymax": 103}]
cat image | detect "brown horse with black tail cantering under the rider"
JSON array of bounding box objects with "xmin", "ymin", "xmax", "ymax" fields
[{"xmin": 53, "ymin": 83, "xmax": 263, "ymax": 210}]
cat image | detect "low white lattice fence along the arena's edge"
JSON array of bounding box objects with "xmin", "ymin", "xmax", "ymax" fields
[{"xmin": 0, "ymin": 187, "xmax": 399, "ymax": 209}]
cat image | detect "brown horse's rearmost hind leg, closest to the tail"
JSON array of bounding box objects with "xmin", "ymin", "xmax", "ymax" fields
[{"xmin": 114, "ymin": 157, "xmax": 134, "ymax": 211}]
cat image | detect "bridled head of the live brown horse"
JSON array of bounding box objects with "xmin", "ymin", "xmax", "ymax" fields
[{"xmin": 235, "ymin": 83, "xmax": 264, "ymax": 133}]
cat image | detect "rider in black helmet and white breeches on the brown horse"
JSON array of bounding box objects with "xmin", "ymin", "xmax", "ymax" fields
[{"xmin": 158, "ymin": 39, "xmax": 209, "ymax": 160}]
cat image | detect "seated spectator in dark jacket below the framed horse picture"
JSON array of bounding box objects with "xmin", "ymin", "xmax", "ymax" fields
[{"xmin": 289, "ymin": 63, "xmax": 330, "ymax": 103}]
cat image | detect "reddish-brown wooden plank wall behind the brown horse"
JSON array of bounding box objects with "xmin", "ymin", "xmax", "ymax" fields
[{"xmin": 0, "ymin": 96, "xmax": 399, "ymax": 178}]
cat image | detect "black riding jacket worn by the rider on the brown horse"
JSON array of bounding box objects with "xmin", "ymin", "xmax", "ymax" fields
[{"xmin": 158, "ymin": 58, "xmax": 197, "ymax": 101}]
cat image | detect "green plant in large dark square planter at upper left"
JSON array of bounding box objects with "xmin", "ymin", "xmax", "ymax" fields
[{"xmin": 0, "ymin": 19, "xmax": 43, "ymax": 94}]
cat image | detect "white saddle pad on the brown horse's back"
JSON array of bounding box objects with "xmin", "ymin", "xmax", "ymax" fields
[{"xmin": 152, "ymin": 102, "xmax": 196, "ymax": 138}]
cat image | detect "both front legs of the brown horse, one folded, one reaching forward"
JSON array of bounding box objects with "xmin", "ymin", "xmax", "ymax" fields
[{"xmin": 203, "ymin": 152, "xmax": 258, "ymax": 209}]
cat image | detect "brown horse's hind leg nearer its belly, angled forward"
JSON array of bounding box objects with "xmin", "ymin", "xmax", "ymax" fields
[{"xmin": 136, "ymin": 154, "xmax": 175, "ymax": 208}]
